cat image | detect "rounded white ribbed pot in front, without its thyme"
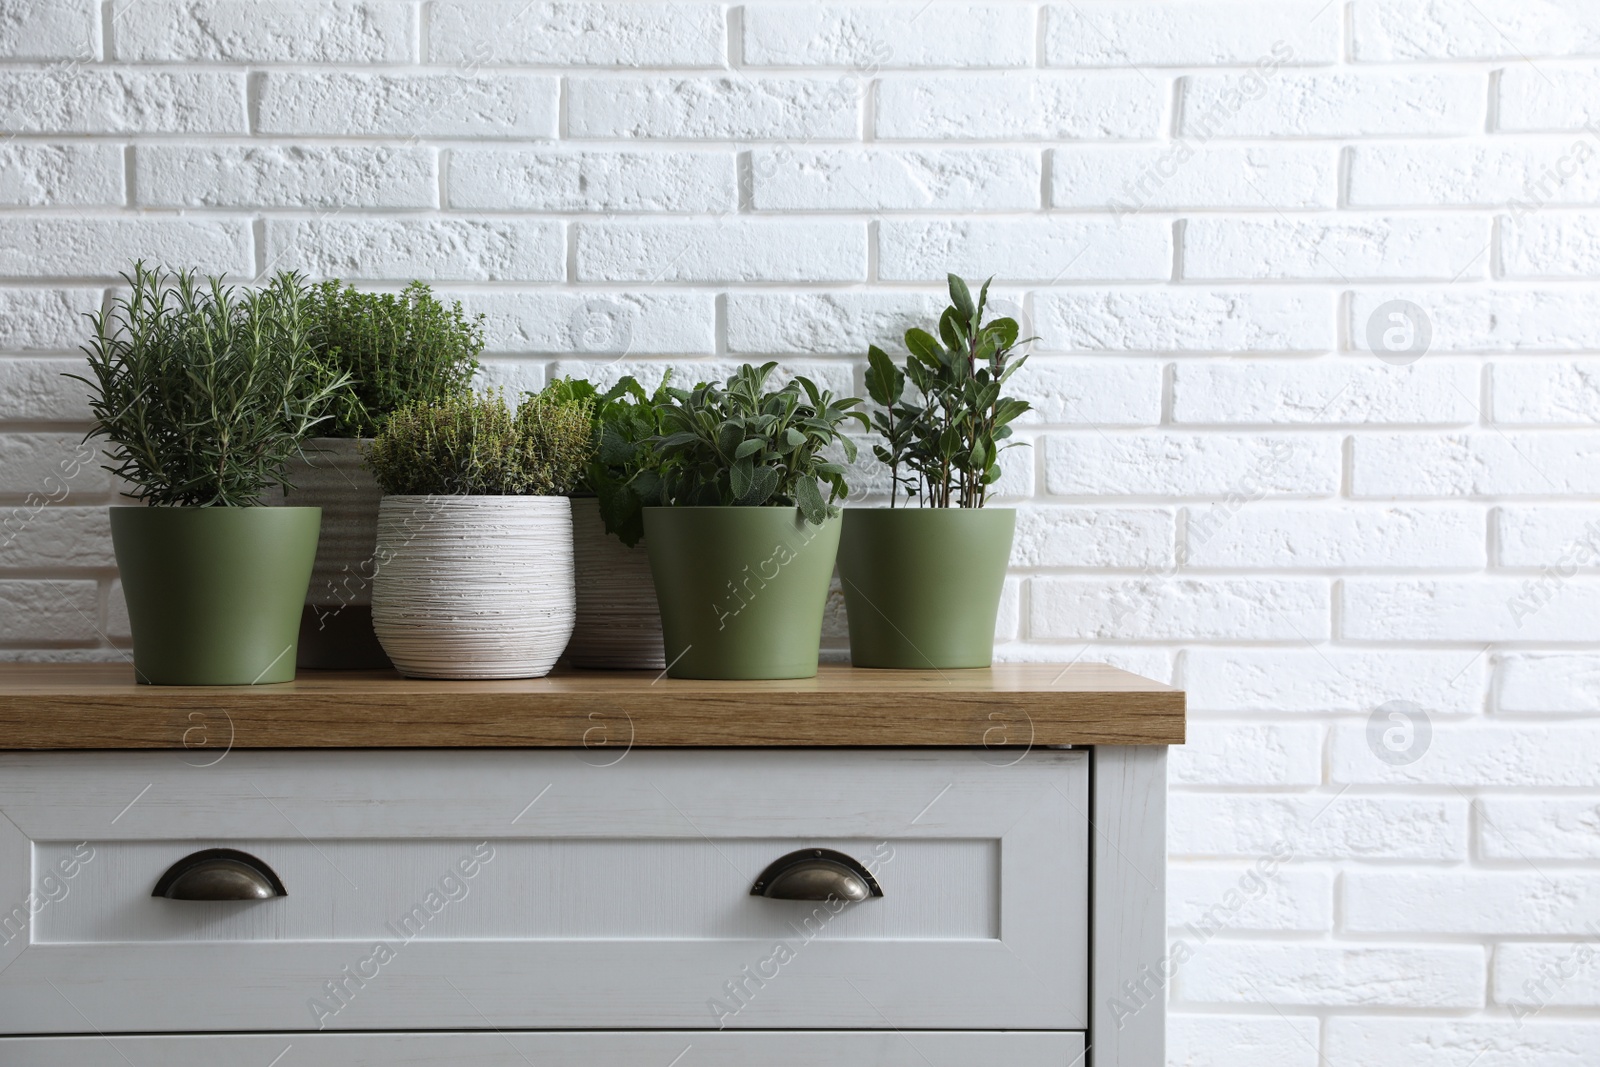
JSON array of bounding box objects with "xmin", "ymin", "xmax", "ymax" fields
[{"xmin": 373, "ymin": 496, "xmax": 576, "ymax": 678}]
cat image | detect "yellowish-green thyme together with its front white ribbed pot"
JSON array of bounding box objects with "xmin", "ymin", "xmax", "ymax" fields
[{"xmin": 366, "ymin": 390, "xmax": 594, "ymax": 678}]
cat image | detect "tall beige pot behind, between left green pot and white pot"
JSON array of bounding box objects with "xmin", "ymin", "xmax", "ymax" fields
[{"xmin": 269, "ymin": 437, "xmax": 389, "ymax": 670}]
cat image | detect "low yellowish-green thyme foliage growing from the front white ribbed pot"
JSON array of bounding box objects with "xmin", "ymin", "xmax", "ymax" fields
[{"xmin": 366, "ymin": 387, "xmax": 595, "ymax": 496}]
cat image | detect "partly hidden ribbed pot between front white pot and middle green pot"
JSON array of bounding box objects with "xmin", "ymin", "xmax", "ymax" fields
[{"xmin": 566, "ymin": 496, "xmax": 667, "ymax": 670}]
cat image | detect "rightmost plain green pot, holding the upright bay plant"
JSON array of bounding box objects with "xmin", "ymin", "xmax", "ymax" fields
[{"xmin": 838, "ymin": 507, "xmax": 1016, "ymax": 670}]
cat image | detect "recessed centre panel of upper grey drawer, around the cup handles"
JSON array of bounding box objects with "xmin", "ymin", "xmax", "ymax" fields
[{"xmin": 34, "ymin": 838, "xmax": 1000, "ymax": 944}]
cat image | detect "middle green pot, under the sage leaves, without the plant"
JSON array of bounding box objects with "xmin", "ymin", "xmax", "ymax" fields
[{"xmin": 645, "ymin": 507, "xmax": 840, "ymax": 678}]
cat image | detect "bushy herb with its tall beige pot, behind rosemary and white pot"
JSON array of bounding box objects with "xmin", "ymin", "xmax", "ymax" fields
[{"xmin": 272, "ymin": 280, "xmax": 483, "ymax": 669}]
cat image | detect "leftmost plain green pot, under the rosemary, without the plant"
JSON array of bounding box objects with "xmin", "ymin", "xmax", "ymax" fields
[{"xmin": 110, "ymin": 507, "xmax": 322, "ymax": 685}]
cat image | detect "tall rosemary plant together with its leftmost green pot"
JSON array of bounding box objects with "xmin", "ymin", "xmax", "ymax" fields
[{"xmin": 72, "ymin": 262, "xmax": 344, "ymax": 685}]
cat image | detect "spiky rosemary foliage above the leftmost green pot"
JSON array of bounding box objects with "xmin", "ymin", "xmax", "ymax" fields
[{"xmin": 69, "ymin": 262, "xmax": 349, "ymax": 507}]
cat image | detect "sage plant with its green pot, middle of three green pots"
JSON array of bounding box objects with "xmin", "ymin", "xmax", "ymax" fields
[{"xmin": 645, "ymin": 363, "xmax": 867, "ymax": 678}]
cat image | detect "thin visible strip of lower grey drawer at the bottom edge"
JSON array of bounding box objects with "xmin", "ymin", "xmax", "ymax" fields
[{"xmin": 0, "ymin": 1030, "xmax": 1083, "ymax": 1067}]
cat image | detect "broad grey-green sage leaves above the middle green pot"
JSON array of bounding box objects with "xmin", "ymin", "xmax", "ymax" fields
[{"xmin": 653, "ymin": 363, "xmax": 870, "ymax": 525}]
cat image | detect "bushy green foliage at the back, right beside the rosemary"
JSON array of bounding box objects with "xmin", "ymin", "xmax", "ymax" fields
[{"xmin": 307, "ymin": 280, "xmax": 483, "ymax": 437}]
